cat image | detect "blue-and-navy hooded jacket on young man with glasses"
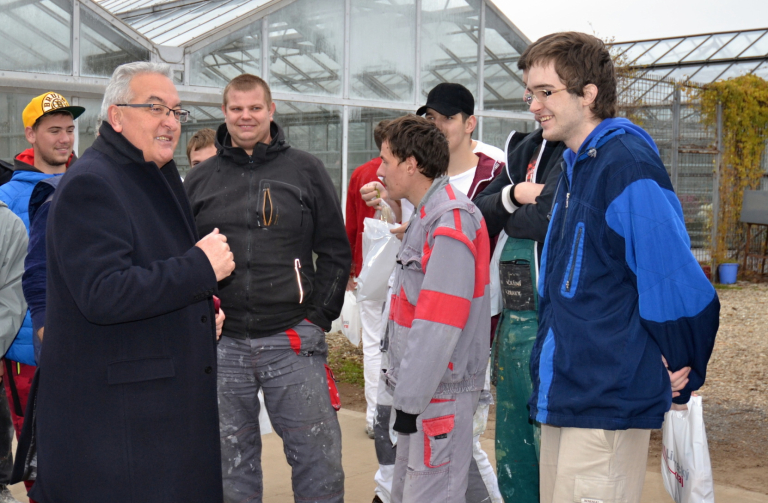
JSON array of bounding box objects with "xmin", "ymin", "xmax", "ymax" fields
[{"xmin": 529, "ymin": 119, "xmax": 720, "ymax": 430}]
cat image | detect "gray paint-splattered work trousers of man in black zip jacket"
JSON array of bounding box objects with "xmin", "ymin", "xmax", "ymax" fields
[{"xmin": 218, "ymin": 321, "xmax": 344, "ymax": 503}]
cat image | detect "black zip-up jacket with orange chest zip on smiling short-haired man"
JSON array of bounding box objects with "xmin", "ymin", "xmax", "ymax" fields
[{"xmin": 184, "ymin": 122, "xmax": 352, "ymax": 339}]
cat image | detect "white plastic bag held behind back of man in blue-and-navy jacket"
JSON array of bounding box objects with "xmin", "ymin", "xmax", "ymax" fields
[{"xmin": 661, "ymin": 396, "xmax": 715, "ymax": 503}]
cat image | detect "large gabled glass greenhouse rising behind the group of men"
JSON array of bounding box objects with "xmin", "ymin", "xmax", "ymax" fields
[{"xmin": 0, "ymin": 0, "xmax": 534, "ymax": 207}]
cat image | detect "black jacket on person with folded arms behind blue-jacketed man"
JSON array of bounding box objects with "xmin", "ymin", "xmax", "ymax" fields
[{"xmin": 473, "ymin": 129, "xmax": 565, "ymax": 257}]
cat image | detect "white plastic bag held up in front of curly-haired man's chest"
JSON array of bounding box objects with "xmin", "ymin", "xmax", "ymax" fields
[{"xmin": 357, "ymin": 218, "xmax": 400, "ymax": 302}]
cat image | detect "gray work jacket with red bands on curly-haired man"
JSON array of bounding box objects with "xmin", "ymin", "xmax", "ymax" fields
[{"xmin": 385, "ymin": 177, "xmax": 491, "ymax": 414}]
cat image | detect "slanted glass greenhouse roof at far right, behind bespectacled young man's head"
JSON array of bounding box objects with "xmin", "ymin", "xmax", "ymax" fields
[{"xmin": 611, "ymin": 28, "xmax": 768, "ymax": 84}]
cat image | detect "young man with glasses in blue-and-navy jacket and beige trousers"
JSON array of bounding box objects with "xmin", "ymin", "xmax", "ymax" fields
[{"xmin": 524, "ymin": 33, "xmax": 720, "ymax": 503}]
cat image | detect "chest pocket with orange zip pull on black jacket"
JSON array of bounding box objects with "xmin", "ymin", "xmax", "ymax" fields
[{"xmin": 256, "ymin": 180, "xmax": 309, "ymax": 230}]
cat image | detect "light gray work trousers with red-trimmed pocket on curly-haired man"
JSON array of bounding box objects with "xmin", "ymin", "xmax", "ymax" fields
[{"xmin": 392, "ymin": 391, "xmax": 480, "ymax": 503}]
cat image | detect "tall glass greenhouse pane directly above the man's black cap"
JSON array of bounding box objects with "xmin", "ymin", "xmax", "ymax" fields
[{"xmin": 417, "ymin": 0, "xmax": 480, "ymax": 103}]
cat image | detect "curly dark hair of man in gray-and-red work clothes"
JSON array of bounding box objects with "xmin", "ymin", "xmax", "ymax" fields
[{"xmin": 381, "ymin": 114, "xmax": 451, "ymax": 180}]
